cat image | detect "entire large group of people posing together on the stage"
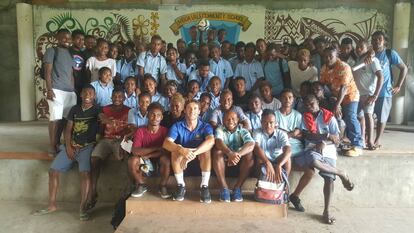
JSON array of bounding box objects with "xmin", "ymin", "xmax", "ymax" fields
[{"xmin": 35, "ymin": 26, "xmax": 407, "ymax": 224}]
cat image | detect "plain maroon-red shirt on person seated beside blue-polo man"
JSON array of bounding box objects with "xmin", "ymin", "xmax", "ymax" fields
[{"xmin": 132, "ymin": 125, "xmax": 168, "ymax": 148}]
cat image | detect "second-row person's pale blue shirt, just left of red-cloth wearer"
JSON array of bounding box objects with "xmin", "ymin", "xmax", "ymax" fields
[{"xmin": 275, "ymin": 109, "xmax": 303, "ymax": 157}]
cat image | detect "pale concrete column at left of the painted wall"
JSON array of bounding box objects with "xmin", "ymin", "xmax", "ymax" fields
[{"xmin": 16, "ymin": 3, "xmax": 36, "ymax": 121}]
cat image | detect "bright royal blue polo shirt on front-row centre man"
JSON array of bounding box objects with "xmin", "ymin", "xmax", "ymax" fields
[{"xmin": 168, "ymin": 119, "xmax": 214, "ymax": 148}]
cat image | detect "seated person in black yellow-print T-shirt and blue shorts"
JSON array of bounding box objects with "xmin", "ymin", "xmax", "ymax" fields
[{"xmin": 34, "ymin": 85, "xmax": 101, "ymax": 221}]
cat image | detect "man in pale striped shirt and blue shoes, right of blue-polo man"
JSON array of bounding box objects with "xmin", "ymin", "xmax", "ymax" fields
[{"xmin": 212, "ymin": 110, "xmax": 254, "ymax": 202}]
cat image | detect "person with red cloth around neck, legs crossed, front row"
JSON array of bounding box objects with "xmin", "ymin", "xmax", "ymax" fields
[{"xmin": 292, "ymin": 95, "xmax": 354, "ymax": 224}]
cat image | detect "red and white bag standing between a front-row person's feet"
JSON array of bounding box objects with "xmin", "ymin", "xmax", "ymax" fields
[{"xmin": 254, "ymin": 165, "xmax": 290, "ymax": 205}]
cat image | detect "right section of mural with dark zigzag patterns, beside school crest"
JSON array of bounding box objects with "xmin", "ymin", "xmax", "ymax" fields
[{"xmin": 265, "ymin": 8, "xmax": 388, "ymax": 44}]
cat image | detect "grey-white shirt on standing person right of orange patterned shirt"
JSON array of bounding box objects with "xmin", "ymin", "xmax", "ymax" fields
[{"xmin": 353, "ymin": 57, "xmax": 382, "ymax": 96}]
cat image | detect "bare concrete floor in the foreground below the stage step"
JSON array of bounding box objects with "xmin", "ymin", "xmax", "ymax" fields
[{"xmin": 0, "ymin": 201, "xmax": 414, "ymax": 233}]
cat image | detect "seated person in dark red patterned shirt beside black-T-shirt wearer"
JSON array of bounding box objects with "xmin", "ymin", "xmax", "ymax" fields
[{"xmin": 88, "ymin": 88, "xmax": 129, "ymax": 209}]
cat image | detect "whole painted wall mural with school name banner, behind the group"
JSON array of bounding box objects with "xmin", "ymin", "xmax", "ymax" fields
[{"xmin": 33, "ymin": 5, "xmax": 389, "ymax": 119}]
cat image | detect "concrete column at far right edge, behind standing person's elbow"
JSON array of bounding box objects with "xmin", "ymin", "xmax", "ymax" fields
[{"xmin": 391, "ymin": 2, "xmax": 411, "ymax": 124}]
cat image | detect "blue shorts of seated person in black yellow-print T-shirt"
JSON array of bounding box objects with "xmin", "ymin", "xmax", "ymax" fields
[{"xmin": 50, "ymin": 144, "xmax": 94, "ymax": 172}]
